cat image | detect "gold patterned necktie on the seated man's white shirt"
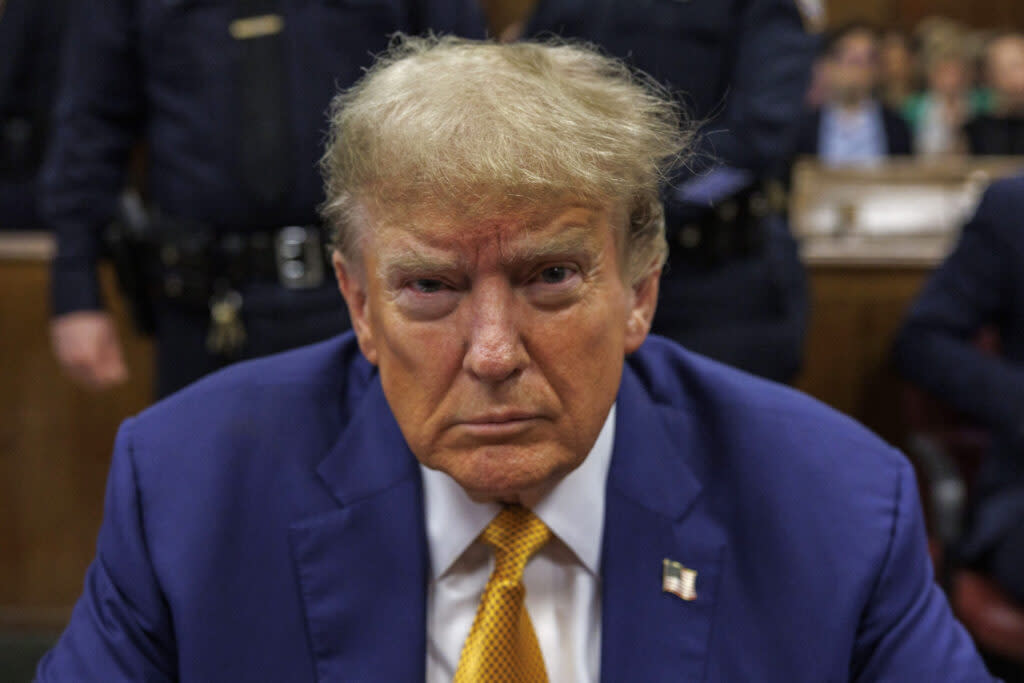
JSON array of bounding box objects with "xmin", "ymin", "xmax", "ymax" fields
[{"xmin": 454, "ymin": 505, "xmax": 551, "ymax": 683}]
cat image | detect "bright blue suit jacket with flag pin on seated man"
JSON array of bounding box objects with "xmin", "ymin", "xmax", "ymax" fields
[{"xmin": 39, "ymin": 336, "xmax": 990, "ymax": 683}]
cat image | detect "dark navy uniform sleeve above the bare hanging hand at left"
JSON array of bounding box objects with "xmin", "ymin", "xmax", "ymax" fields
[{"xmin": 42, "ymin": 0, "xmax": 143, "ymax": 314}]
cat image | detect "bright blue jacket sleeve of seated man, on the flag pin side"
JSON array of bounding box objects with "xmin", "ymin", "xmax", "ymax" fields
[{"xmin": 851, "ymin": 459, "xmax": 994, "ymax": 683}]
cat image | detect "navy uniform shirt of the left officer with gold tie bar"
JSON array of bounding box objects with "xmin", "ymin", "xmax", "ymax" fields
[{"xmin": 43, "ymin": 0, "xmax": 468, "ymax": 314}]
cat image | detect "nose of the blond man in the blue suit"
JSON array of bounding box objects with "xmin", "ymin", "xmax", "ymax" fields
[{"xmin": 463, "ymin": 286, "xmax": 528, "ymax": 383}]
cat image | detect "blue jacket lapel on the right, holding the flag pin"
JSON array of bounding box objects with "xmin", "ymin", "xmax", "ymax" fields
[{"xmin": 601, "ymin": 366, "xmax": 725, "ymax": 682}]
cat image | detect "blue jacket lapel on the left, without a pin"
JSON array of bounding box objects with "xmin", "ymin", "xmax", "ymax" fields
[{"xmin": 290, "ymin": 379, "xmax": 428, "ymax": 683}]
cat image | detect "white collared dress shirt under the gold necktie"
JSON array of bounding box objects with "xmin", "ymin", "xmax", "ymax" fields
[{"xmin": 422, "ymin": 405, "xmax": 615, "ymax": 683}]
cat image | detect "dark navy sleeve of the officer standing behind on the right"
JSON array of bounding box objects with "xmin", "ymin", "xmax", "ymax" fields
[{"xmin": 699, "ymin": 0, "xmax": 817, "ymax": 173}]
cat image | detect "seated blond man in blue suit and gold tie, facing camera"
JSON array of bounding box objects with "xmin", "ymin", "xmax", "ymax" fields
[{"xmin": 39, "ymin": 39, "xmax": 991, "ymax": 683}]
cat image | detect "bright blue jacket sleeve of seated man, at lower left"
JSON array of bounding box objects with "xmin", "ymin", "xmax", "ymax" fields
[{"xmin": 37, "ymin": 422, "xmax": 177, "ymax": 683}]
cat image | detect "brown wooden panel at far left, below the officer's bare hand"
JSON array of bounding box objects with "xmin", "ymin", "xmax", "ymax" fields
[{"xmin": 0, "ymin": 250, "xmax": 152, "ymax": 628}]
